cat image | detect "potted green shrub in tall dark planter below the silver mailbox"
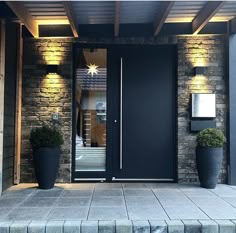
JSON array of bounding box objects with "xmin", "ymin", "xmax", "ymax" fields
[{"xmin": 196, "ymin": 128, "xmax": 226, "ymax": 189}]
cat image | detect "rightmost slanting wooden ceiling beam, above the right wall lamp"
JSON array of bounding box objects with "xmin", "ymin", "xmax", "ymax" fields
[{"xmin": 192, "ymin": 1, "xmax": 224, "ymax": 34}]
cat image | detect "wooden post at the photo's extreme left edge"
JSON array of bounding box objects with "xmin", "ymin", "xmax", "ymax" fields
[{"xmin": 0, "ymin": 19, "xmax": 5, "ymax": 195}]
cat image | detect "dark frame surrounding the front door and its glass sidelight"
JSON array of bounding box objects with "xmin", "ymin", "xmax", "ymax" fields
[{"xmin": 71, "ymin": 41, "xmax": 178, "ymax": 183}]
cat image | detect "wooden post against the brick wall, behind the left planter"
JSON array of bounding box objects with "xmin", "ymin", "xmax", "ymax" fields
[{"xmin": 14, "ymin": 24, "xmax": 23, "ymax": 184}]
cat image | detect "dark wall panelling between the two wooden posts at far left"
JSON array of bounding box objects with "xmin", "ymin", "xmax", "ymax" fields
[{"xmin": 2, "ymin": 22, "xmax": 18, "ymax": 190}]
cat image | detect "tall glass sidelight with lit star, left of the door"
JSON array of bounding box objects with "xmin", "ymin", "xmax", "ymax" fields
[{"xmin": 75, "ymin": 49, "xmax": 107, "ymax": 171}]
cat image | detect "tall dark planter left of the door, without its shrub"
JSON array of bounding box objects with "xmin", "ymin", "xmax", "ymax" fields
[{"xmin": 33, "ymin": 147, "xmax": 60, "ymax": 189}]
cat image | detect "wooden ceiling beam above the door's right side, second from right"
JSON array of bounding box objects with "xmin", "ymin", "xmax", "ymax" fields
[{"xmin": 154, "ymin": 1, "xmax": 174, "ymax": 36}]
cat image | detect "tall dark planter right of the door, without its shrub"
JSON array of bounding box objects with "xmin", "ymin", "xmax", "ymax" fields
[{"xmin": 197, "ymin": 147, "xmax": 223, "ymax": 189}]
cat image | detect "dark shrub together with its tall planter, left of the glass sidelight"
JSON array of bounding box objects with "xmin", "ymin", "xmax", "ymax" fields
[{"xmin": 30, "ymin": 126, "xmax": 63, "ymax": 189}]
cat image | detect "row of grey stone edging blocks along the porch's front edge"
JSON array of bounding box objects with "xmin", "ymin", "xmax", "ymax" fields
[{"xmin": 0, "ymin": 220, "xmax": 236, "ymax": 233}]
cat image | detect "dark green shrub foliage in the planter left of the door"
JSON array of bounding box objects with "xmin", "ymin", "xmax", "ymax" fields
[{"xmin": 30, "ymin": 126, "xmax": 64, "ymax": 149}]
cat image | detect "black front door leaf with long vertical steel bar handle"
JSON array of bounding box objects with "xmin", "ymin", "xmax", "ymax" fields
[{"xmin": 109, "ymin": 46, "xmax": 176, "ymax": 181}]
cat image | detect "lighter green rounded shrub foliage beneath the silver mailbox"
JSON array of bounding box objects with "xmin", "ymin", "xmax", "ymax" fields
[{"xmin": 197, "ymin": 128, "xmax": 226, "ymax": 147}]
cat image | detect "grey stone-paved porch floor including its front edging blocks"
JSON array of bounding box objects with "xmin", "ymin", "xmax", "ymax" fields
[{"xmin": 0, "ymin": 183, "xmax": 236, "ymax": 233}]
